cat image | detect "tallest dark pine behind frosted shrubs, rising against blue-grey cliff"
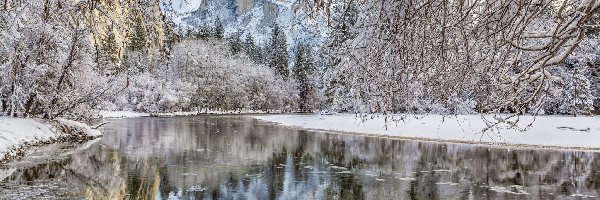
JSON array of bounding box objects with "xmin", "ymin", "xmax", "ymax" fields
[{"xmin": 268, "ymin": 24, "xmax": 290, "ymax": 79}]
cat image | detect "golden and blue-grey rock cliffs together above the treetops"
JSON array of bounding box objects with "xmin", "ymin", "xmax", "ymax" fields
[{"xmin": 89, "ymin": 0, "xmax": 329, "ymax": 62}]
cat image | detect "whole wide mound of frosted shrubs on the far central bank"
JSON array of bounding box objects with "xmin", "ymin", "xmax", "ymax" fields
[{"xmin": 103, "ymin": 40, "xmax": 297, "ymax": 112}]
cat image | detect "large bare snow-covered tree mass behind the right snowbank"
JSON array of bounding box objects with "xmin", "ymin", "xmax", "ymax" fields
[{"xmin": 316, "ymin": 0, "xmax": 600, "ymax": 117}]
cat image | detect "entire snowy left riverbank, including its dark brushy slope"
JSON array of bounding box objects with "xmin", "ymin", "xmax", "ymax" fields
[{"xmin": 0, "ymin": 117, "xmax": 102, "ymax": 163}]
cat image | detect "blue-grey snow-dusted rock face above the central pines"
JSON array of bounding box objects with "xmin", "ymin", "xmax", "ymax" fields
[{"xmin": 179, "ymin": 0, "xmax": 329, "ymax": 59}]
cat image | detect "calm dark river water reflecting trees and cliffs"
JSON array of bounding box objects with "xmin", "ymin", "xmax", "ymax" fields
[{"xmin": 0, "ymin": 116, "xmax": 600, "ymax": 199}]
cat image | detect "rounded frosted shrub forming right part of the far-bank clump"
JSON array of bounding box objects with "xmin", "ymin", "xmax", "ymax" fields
[{"xmin": 183, "ymin": 40, "xmax": 297, "ymax": 110}]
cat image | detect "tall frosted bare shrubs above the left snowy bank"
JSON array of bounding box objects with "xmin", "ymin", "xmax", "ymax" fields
[{"xmin": 0, "ymin": 0, "xmax": 113, "ymax": 118}]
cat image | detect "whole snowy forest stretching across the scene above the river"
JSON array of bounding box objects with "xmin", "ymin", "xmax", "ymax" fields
[{"xmin": 0, "ymin": 0, "xmax": 600, "ymax": 120}]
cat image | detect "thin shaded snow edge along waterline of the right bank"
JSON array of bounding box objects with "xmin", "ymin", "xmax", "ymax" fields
[{"xmin": 251, "ymin": 116, "xmax": 600, "ymax": 153}]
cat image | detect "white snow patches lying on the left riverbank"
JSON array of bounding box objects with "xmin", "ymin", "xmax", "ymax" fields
[{"xmin": 0, "ymin": 117, "xmax": 102, "ymax": 161}]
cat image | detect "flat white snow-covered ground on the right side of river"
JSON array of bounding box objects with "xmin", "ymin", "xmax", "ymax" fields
[{"xmin": 253, "ymin": 114, "xmax": 600, "ymax": 149}]
